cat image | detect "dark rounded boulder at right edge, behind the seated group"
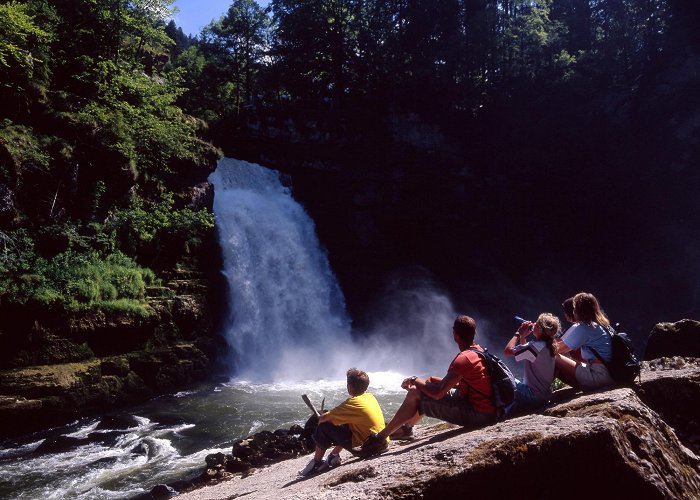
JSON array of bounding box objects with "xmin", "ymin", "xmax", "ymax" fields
[{"xmin": 644, "ymin": 319, "xmax": 700, "ymax": 361}]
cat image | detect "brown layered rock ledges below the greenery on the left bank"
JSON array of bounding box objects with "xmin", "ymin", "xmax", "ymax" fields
[{"xmin": 0, "ymin": 266, "xmax": 227, "ymax": 437}]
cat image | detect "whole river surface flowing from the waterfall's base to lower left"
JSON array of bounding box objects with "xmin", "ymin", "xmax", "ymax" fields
[{"xmin": 0, "ymin": 372, "xmax": 410, "ymax": 499}]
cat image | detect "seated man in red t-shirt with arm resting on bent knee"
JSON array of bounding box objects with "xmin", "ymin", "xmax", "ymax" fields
[{"xmin": 360, "ymin": 316, "xmax": 496, "ymax": 456}]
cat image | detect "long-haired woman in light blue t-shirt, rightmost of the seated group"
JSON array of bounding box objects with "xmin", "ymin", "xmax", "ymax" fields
[{"xmin": 555, "ymin": 292, "xmax": 613, "ymax": 390}]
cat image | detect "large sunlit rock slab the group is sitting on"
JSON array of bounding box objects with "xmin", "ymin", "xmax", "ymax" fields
[{"xmin": 178, "ymin": 358, "xmax": 700, "ymax": 500}]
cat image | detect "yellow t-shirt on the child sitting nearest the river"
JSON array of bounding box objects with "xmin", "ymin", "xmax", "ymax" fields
[{"xmin": 328, "ymin": 392, "xmax": 384, "ymax": 446}]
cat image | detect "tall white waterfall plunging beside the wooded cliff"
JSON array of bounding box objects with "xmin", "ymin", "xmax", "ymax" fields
[{"xmin": 209, "ymin": 158, "xmax": 350, "ymax": 381}]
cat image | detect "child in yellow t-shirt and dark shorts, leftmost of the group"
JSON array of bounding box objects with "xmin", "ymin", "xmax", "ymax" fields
[{"xmin": 299, "ymin": 368, "xmax": 388, "ymax": 476}]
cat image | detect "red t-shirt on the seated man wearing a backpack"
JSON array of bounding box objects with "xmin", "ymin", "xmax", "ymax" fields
[{"xmin": 447, "ymin": 344, "xmax": 496, "ymax": 413}]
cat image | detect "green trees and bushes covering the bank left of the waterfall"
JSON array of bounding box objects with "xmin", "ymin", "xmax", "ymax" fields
[{"xmin": 0, "ymin": 0, "xmax": 217, "ymax": 312}]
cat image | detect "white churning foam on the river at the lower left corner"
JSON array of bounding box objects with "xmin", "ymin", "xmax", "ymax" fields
[{"xmin": 0, "ymin": 416, "xmax": 213, "ymax": 499}]
